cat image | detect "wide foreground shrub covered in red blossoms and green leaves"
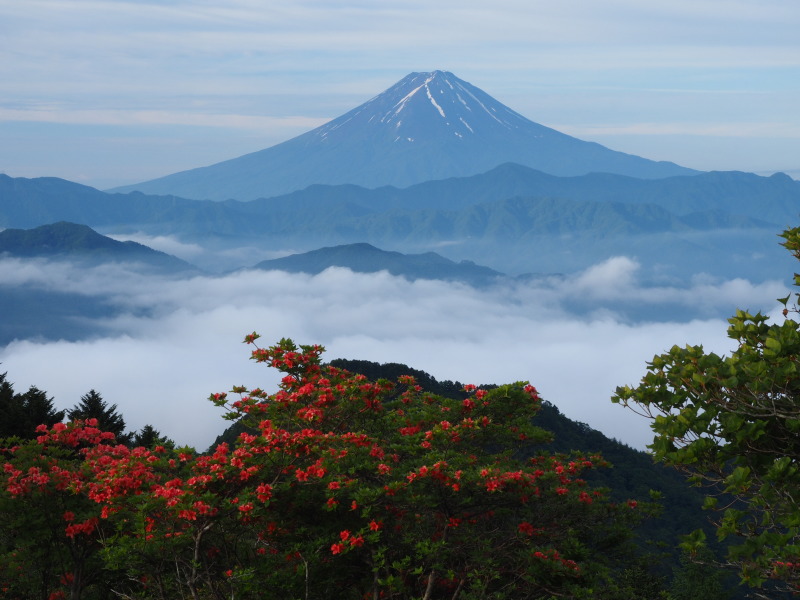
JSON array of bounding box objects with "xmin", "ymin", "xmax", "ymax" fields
[{"xmin": 0, "ymin": 334, "xmax": 640, "ymax": 600}]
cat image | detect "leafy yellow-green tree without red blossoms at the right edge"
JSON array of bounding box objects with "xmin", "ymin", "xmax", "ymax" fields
[{"xmin": 614, "ymin": 228, "xmax": 800, "ymax": 591}]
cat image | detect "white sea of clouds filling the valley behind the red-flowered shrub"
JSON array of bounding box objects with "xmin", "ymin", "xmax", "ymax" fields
[{"xmin": 0, "ymin": 258, "xmax": 785, "ymax": 449}]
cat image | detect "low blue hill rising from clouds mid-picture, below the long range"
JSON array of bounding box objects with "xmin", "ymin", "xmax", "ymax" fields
[{"xmin": 254, "ymin": 243, "xmax": 505, "ymax": 286}]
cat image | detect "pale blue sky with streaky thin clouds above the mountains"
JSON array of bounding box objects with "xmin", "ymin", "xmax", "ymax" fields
[{"xmin": 0, "ymin": 0, "xmax": 800, "ymax": 188}]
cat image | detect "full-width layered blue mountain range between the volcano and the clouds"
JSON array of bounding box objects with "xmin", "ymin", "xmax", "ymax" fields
[{"xmin": 0, "ymin": 164, "xmax": 800, "ymax": 280}]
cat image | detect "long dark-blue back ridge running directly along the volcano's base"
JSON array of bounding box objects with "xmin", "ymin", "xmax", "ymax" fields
[{"xmin": 0, "ymin": 169, "xmax": 800, "ymax": 236}]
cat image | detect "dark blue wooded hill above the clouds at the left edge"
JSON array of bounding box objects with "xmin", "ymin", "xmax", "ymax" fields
[{"xmin": 0, "ymin": 221, "xmax": 194, "ymax": 271}]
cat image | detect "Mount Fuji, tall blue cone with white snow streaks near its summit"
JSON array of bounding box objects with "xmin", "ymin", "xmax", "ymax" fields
[{"xmin": 113, "ymin": 71, "xmax": 696, "ymax": 200}]
